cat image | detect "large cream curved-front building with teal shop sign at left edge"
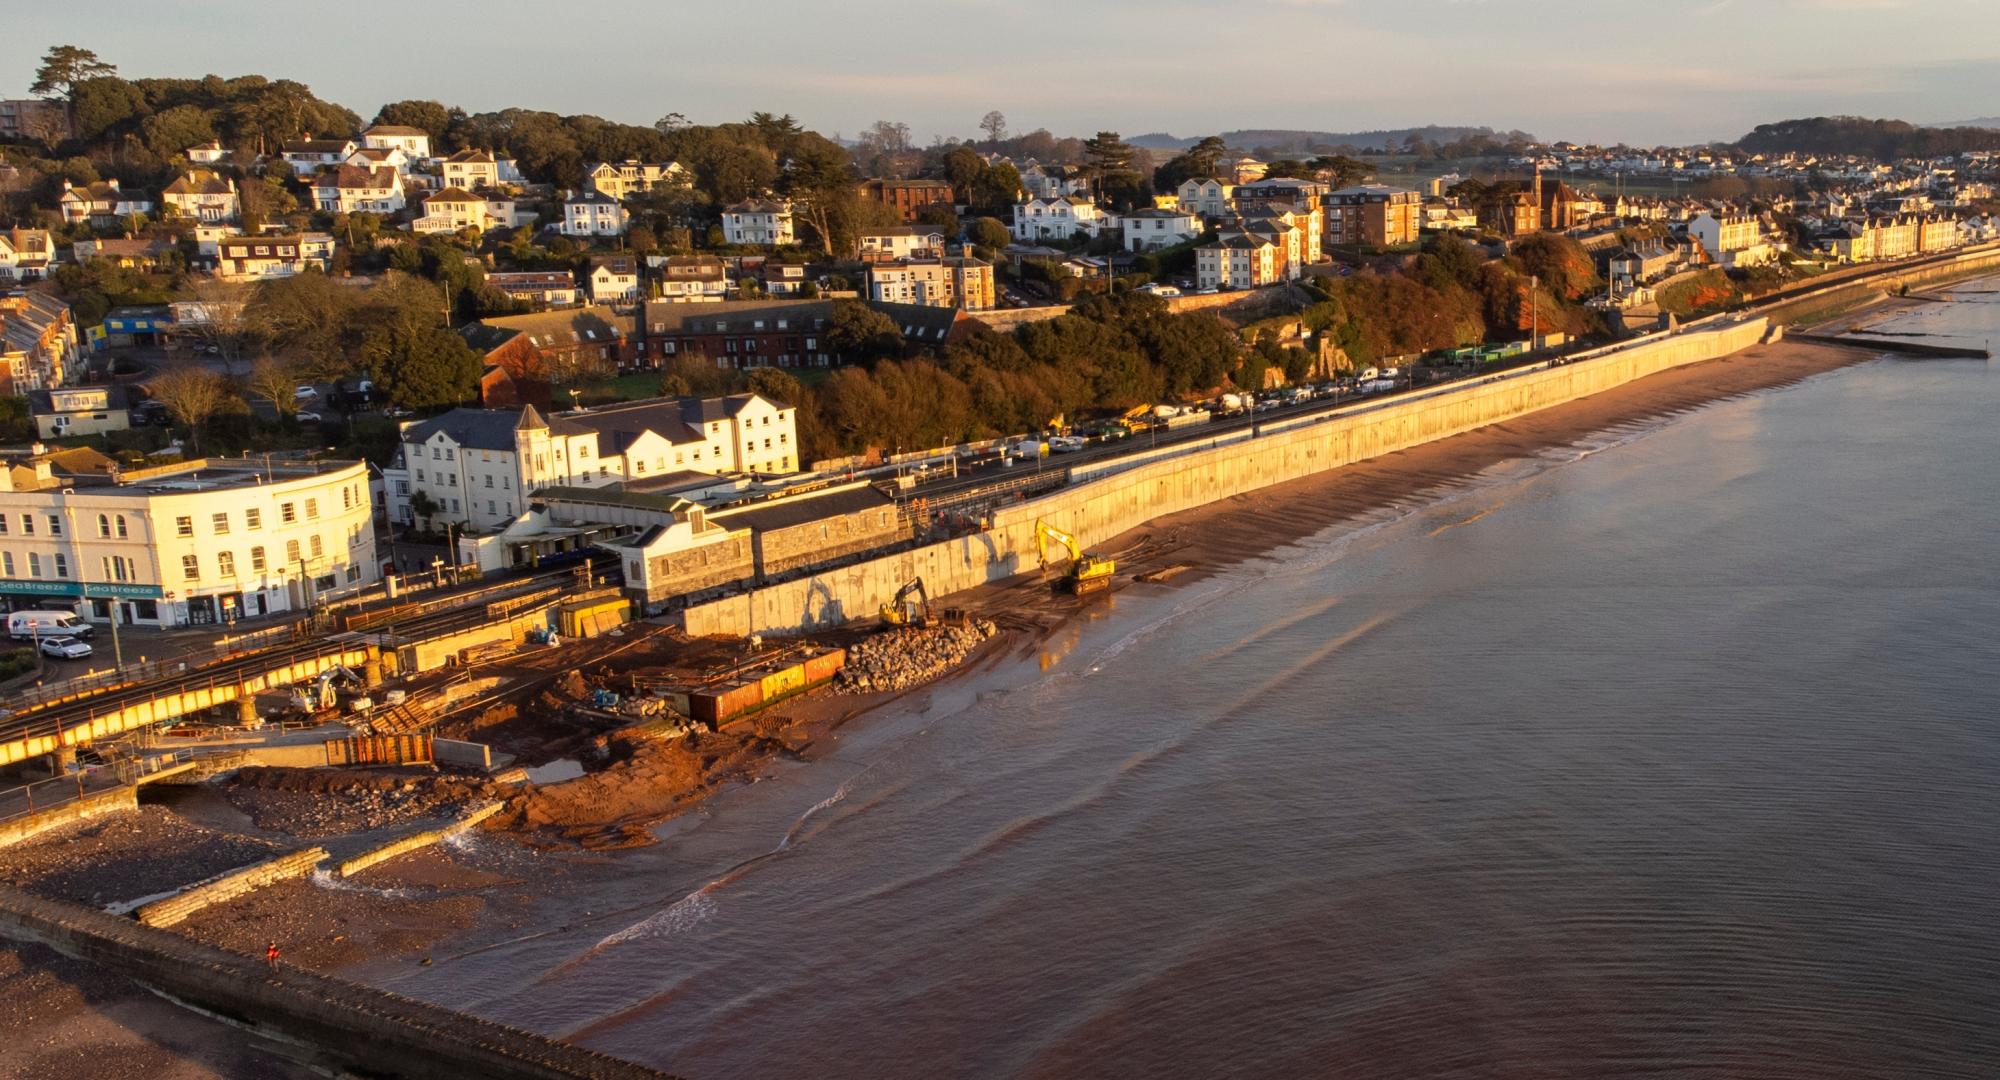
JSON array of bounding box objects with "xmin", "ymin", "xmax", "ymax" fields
[{"xmin": 0, "ymin": 458, "xmax": 380, "ymax": 626}]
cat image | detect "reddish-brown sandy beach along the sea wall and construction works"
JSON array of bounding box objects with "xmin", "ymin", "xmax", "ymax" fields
[{"xmin": 0, "ymin": 334, "xmax": 1888, "ymax": 1076}]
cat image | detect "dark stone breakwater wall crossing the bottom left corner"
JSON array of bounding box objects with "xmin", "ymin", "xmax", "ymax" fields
[{"xmin": 0, "ymin": 888, "xmax": 664, "ymax": 1080}]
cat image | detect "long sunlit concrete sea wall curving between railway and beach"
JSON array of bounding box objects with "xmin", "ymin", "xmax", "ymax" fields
[{"xmin": 682, "ymin": 318, "xmax": 1772, "ymax": 636}]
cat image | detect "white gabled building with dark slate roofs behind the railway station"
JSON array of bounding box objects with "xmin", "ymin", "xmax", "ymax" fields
[{"xmin": 384, "ymin": 394, "xmax": 798, "ymax": 532}]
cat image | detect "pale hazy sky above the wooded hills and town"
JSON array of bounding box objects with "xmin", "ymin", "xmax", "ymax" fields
[{"xmin": 0, "ymin": 0, "xmax": 2000, "ymax": 144}]
